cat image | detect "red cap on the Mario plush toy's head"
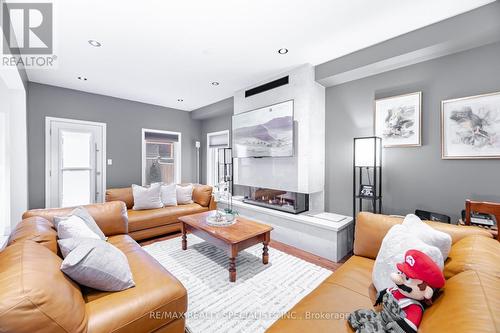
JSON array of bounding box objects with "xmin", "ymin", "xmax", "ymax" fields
[{"xmin": 396, "ymin": 250, "xmax": 445, "ymax": 288}]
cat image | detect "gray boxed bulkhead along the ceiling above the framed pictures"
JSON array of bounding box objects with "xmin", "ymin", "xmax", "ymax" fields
[{"xmin": 316, "ymin": 1, "xmax": 500, "ymax": 87}]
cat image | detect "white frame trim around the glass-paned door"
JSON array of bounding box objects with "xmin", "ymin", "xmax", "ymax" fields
[{"xmin": 45, "ymin": 117, "xmax": 107, "ymax": 208}]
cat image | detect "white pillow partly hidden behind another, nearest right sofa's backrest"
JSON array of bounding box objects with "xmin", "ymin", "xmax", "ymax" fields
[{"xmin": 403, "ymin": 214, "xmax": 451, "ymax": 260}]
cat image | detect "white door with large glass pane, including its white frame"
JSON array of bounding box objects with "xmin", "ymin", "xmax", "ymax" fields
[{"xmin": 45, "ymin": 117, "xmax": 106, "ymax": 208}]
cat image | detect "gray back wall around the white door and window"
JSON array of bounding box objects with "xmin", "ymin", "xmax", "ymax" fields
[{"xmin": 28, "ymin": 82, "xmax": 200, "ymax": 208}]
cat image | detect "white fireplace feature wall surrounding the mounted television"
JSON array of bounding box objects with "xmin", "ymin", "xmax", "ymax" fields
[{"xmin": 234, "ymin": 65, "xmax": 325, "ymax": 206}]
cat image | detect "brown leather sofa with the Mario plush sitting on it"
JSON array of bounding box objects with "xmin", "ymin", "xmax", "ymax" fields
[{"xmin": 267, "ymin": 213, "xmax": 500, "ymax": 333}]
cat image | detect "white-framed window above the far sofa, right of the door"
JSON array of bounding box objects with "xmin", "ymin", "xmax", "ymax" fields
[{"xmin": 142, "ymin": 129, "xmax": 181, "ymax": 185}]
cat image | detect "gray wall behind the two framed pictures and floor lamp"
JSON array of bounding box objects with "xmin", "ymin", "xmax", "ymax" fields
[{"xmin": 325, "ymin": 43, "xmax": 500, "ymax": 220}]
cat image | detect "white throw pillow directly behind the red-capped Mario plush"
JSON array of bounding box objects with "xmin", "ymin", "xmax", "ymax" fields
[{"xmin": 372, "ymin": 224, "xmax": 444, "ymax": 291}]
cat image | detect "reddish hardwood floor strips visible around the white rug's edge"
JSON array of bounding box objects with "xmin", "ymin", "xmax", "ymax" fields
[{"xmin": 139, "ymin": 232, "xmax": 352, "ymax": 272}]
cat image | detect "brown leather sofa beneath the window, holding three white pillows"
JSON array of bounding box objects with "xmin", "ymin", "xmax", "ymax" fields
[{"xmin": 106, "ymin": 185, "xmax": 216, "ymax": 241}]
